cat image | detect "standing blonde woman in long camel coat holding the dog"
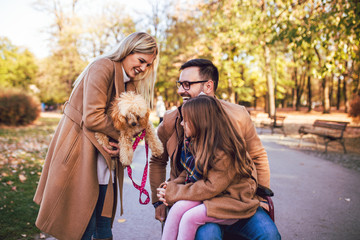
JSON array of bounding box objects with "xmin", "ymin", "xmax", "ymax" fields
[{"xmin": 34, "ymin": 32, "xmax": 159, "ymax": 240}]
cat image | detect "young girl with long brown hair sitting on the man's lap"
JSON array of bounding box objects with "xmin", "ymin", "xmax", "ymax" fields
[{"xmin": 158, "ymin": 95, "xmax": 259, "ymax": 240}]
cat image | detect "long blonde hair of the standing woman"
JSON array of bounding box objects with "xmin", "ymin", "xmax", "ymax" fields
[{"xmin": 74, "ymin": 32, "xmax": 159, "ymax": 108}]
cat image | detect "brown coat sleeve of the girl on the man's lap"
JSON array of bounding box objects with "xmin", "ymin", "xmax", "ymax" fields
[{"xmin": 165, "ymin": 155, "xmax": 236, "ymax": 205}]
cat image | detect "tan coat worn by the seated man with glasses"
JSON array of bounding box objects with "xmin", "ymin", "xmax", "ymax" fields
[{"xmin": 149, "ymin": 100, "xmax": 270, "ymax": 203}]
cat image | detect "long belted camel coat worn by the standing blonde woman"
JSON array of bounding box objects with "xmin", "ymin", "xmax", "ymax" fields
[{"xmin": 34, "ymin": 59, "xmax": 135, "ymax": 240}]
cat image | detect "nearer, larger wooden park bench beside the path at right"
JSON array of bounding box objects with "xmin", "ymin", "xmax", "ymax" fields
[{"xmin": 299, "ymin": 120, "xmax": 349, "ymax": 153}]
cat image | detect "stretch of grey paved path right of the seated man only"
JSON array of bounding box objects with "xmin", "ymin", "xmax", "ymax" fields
[{"xmin": 260, "ymin": 135, "xmax": 360, "ymax": 240}]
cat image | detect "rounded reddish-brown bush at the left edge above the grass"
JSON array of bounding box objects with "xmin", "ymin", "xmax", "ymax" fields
[{"xmin": 0, "ymin": 90, "xmax": 41, "ymax": 126}]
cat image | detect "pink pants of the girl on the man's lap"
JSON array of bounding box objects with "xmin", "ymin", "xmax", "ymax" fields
[{"xmin": 161, "ymin": 200, "xmax": 238, "ymax": 240}]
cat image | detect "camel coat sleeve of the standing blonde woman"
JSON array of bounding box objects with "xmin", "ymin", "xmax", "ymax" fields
[{"xmin": 83, "ymin": 59, "xmax": 119, "ymax": 139}]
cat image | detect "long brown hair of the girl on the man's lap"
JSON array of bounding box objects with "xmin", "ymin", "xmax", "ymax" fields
[{"xmin": 182, "ymin": 95, "xmax": 252, "ymax": 178}]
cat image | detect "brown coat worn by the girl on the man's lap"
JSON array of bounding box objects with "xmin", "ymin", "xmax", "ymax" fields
[{"xmin": 165, "ymin": 150, "xmax": 259, "ymax": 219}]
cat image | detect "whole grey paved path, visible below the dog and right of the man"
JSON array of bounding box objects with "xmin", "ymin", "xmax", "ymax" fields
[{"xmin": 113, "ymin": 134, "xmax": 360, "ymax": 240}]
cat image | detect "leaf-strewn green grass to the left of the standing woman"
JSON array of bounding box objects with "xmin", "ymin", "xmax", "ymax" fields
[{"xmin": 0, "ymin": 115, "xmax": 59, "ymax": 240}]
